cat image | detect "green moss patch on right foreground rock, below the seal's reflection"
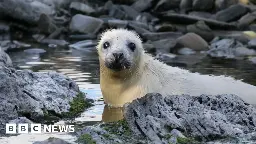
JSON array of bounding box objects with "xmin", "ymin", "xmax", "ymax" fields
[{"xmin": 102, "ymin": 120, "xmax": 132, "ymax": 136}]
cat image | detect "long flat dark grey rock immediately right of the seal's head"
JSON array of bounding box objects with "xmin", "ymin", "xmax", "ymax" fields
[{"xmin": 143, "ymin": 32, "xmax": 182, "ymax": 41}]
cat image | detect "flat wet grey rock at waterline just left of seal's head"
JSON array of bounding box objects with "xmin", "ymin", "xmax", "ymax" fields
[{"xmin": 69, "ymin": 40, "xmax": 97, "ymax": 50}]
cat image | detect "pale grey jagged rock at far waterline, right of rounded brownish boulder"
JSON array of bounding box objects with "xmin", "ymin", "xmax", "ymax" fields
[{"xmin": 207, "ymin": 39, "xmax": 243, "ymax": 58}]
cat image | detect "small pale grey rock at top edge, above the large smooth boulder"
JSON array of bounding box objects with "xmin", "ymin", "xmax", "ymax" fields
[{"xmin": 69, "ymin": 2, "xmax": 95, "ymax": 15}]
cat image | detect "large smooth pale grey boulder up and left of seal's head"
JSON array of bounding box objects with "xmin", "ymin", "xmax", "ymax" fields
[{"xmin": 69, "ymin": 14, "xmax": 103, "ymax": 34}]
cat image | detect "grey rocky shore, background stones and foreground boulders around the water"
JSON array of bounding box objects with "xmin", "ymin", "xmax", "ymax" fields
[{"xmin": 0, "ymin": 0, "xmax": 256, "ymax": 144}]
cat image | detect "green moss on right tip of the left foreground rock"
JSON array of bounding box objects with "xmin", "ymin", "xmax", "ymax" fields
[{"xmin": 62, "ymin": 92, "xmax": 93, "ymax": 118}]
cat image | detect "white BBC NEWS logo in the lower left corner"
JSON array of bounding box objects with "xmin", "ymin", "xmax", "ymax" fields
[{"xmin": 5, "ymin": 123, "xmax": 75, "ymax": 134}]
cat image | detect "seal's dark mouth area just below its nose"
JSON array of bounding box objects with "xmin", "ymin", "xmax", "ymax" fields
[{"xmin": 105, "ymin": 59, "xmax": 131, "ymax": 71}]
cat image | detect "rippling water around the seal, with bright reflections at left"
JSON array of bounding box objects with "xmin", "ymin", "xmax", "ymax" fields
[{"xmin": 0, "ymin": 45, "xmax": 256, "ymax": 144}]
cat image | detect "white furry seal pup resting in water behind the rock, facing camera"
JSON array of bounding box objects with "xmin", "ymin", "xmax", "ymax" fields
[{"xmin": 97, "ymin": 29, "xmax": 256, "ymax": 107}]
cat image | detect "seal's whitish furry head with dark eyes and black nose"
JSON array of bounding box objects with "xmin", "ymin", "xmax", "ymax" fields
[{"xmin": 97, "ymin": 29, "xmax": 143, "ymax": 72}]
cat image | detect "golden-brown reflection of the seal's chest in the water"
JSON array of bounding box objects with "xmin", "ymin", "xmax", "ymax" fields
[{"xmin": 102, "ymin": 105, "xmax": 124, "ymax": 122}]
